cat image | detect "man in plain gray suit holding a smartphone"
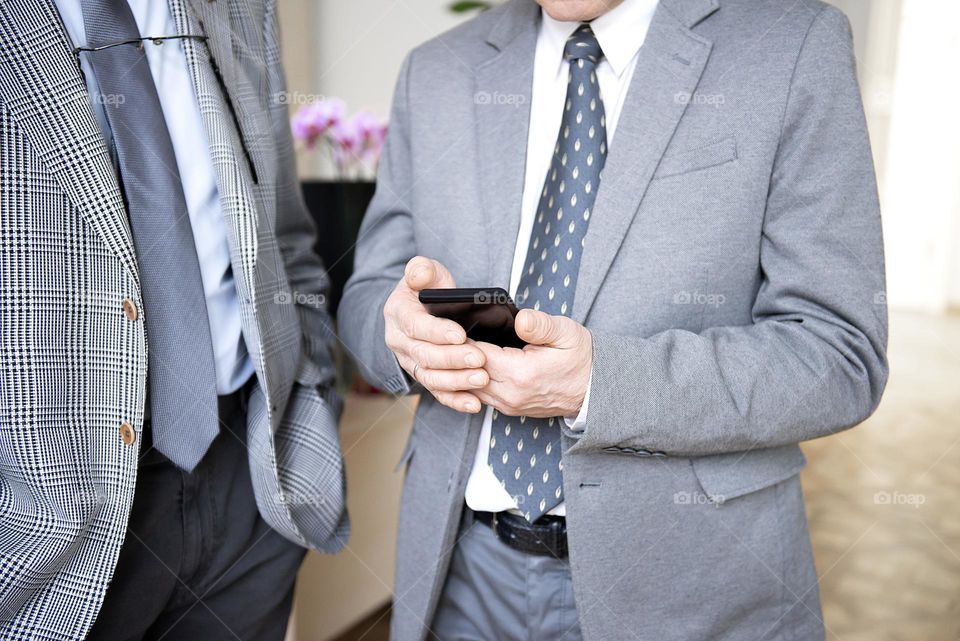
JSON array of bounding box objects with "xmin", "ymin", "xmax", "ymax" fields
[{"xmin": 340, "ymin": 0, "xmax": 887, "ymax": 641}]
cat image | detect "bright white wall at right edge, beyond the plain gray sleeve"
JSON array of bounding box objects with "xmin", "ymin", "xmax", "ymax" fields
[{"xmin": 881, "ymin": 0, "xmax": 960, "ymax": 312}]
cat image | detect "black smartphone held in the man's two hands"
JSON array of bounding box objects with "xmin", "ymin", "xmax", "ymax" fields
[{"xmin": 420, "ymin": 287, "xmax": 526, "ymax": 348}]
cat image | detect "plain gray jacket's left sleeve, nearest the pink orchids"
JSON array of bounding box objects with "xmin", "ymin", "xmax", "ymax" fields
[{"xmin": 338, "ymin": 57, "xmax": 416, "ymax": 394}]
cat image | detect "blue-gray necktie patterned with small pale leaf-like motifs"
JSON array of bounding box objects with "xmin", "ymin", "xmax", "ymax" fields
[{"xmin": 489, "ymin": 24, "xmax": 607, "ymax": 522}]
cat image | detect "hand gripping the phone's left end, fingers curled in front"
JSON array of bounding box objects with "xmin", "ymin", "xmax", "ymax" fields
[{"xmin": 383, "ymin": 256, "xmax": 490, "ymax": 414}]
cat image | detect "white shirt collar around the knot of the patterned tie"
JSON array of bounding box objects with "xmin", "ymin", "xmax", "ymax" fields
[{"xmin": 540, "ymin": 0, "xmax": 657, "ymax": 77}]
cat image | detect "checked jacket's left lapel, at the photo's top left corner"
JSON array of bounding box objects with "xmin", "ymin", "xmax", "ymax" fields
[{"xmin": 0, "ymin": 0, "xmax": 140, "ymax": 287}]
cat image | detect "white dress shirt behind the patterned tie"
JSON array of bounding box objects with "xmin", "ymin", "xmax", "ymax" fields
[{"xmin": 466, "ymin": 0, "xmax": 657, "ymax": 516}]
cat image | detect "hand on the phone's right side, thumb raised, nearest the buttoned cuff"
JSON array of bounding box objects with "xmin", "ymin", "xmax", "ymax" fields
[{"xmin": 473, "ymin": 309, "xmax": 593, "ymax": 418}]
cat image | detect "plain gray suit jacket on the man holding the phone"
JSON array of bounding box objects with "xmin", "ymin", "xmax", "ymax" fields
[{"xmin": 340, "ymin": 0, "xmax": 887, "ymax": 641}]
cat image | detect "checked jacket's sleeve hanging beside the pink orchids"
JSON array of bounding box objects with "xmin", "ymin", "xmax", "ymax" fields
[{"xmin": 265, "ymin": 1, "xmax": 339, "ymax": 400}]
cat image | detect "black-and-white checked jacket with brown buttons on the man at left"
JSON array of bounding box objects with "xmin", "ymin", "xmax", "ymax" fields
[{"xmin": 0, "ymin": 0, "xmax": 349, "ymax": 641}]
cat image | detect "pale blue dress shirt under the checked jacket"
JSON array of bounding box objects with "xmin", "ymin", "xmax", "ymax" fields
[{"xmin": 56, "ymin": 0, "xmax": 253, "ymax": 394}]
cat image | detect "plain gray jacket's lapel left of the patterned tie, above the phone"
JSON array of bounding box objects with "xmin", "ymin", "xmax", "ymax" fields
[{"xmin": 474, "ymin": 0, "xmax": 539, "ymax": 289}]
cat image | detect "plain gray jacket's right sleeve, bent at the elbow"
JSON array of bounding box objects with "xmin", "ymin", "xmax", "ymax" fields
[{"xmin": 570, "ymin": 7, "xmax": 887, "ymax": 456}]
